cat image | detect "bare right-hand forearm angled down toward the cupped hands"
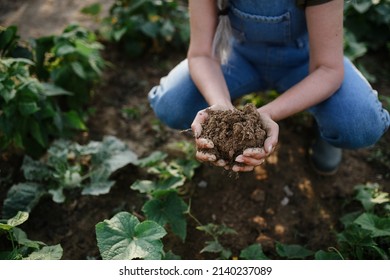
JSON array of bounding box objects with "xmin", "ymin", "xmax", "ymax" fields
[{"xmin": 258, "ymin": 67, "xmax": 343, "ymax": 121}]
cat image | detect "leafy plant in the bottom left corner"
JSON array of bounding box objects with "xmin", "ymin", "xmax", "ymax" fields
[{"xmin": 0, "ymin": 212, "xmax": 62, "ymax": 260}]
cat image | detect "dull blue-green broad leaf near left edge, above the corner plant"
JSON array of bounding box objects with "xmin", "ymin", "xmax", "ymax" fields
[{"xmin": 3, "ymin": 182, "xmax": 45, "ymax": 218}]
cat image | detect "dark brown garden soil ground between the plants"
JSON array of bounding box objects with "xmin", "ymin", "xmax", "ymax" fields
[{"xmin": 0, "ymin": 0, "xmax": 390, "ymax": 259}]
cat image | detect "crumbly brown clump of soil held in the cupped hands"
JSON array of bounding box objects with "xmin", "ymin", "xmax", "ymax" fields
[{"xmin": 199, "ymin": 104, "xmax": 266, "ymax": 166}]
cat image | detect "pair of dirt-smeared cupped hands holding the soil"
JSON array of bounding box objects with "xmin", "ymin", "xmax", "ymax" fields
[{"xmin": 191, "ymin": 105, "xmax": 279, "ymax": 172}]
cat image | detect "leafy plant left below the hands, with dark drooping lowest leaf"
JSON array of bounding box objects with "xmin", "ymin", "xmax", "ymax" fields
[{"xmin": 130, "ymin": 143, "xmax": 199, "ymax": 241}]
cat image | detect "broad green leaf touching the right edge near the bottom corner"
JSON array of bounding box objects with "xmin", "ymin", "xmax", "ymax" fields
[{"xmin": 355, "ymin": 213, "xmax": 390, "ymax": 237}]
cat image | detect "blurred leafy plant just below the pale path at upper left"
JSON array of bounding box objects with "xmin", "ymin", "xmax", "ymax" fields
[{"xmin": 33, "ymin": 24, "xmax": 106, "ymax": 113}]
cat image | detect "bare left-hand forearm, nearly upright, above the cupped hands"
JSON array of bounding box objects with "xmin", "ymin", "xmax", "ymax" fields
[{"xmin": 188, "ymin": 56, "xmax": 233, "ymax": 107}]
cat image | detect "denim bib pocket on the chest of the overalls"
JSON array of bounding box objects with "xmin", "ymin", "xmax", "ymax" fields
[{"xmin": 230, "ymin": 6, "xmax": 291, "ymax": 44}]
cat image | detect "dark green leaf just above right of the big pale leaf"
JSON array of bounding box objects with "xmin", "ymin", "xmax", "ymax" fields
[{"xmin": 142, "ymin": 191, "xmax": 188, "ymax": 241}]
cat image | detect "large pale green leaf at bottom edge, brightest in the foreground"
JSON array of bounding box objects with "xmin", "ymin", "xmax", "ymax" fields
[{"xmin": 96, "ymin": 212, "xmax": 166, "ymax": 260}]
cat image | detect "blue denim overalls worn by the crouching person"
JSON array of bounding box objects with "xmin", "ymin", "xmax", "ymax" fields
[{"xmin": 148, "ymin": 0, "xmax": 390, "ymax": 149}]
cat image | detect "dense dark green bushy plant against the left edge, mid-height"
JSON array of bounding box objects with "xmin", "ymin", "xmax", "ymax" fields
[{"xmin": 0, "ymin": 58, "xmax": 71, "ymax": 155}]
